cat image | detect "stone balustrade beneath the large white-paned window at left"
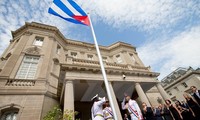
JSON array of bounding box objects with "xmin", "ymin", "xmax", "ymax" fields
[{"xmin": 5, "ymin": 79, "xmax": 35, "ymax": 86}]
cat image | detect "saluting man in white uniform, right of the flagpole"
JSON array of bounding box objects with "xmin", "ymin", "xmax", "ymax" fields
[{"xmin": 122, "ymin": 94, "xmax": 143, "ymax": 120}]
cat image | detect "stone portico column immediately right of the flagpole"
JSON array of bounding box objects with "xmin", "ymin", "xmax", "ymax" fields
[{"xmin": 108, "ymin": 82, "xmax": 122, "ymax": 120}]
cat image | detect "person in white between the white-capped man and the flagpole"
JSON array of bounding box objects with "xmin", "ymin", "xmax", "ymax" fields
[{"xmin": 103, "ymin": 101, "xmax": 114, "ymax": 120}]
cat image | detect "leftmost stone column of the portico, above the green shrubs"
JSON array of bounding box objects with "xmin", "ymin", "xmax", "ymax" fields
[{"xmin": 63, "ymin": 80, "xmax": 74, "ymax": 118}]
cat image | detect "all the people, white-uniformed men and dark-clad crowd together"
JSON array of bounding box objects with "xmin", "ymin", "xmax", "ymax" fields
[{"xmin": 91, "ymin": 86, "xmax": 200, "ymax": 120}]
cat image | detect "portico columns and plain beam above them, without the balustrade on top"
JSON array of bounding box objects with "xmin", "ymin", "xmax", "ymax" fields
[{"xmin": 61, "ymin": 70, "xmax": 167, "ymax": 119}]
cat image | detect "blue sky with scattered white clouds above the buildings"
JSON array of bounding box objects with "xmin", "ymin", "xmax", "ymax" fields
[{"xmin": 0, "ymin": 0, "xmax": 200, "ymax": 80}]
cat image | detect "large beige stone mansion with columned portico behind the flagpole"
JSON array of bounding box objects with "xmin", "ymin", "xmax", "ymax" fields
[{"xmin": 0, "ymin": 22, "xmax": 168, "ymax": 120}]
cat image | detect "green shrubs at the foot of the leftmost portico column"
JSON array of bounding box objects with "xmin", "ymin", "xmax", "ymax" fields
[{"xmin": 43, "ymin": 106, "xmax": 80, "ymax": 120}]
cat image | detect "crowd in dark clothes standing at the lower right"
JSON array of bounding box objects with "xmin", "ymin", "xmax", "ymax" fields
[{"xmin": 141, "ymin": 86, "xmax": 200, "ymax": 120}]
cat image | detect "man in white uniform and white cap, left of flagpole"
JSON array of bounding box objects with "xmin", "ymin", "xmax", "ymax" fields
[{"xmin": 91, "ymin": 94, "xmax": 106, "ymax": 120}]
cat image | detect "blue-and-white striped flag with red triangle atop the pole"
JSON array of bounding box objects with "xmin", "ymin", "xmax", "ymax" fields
[{"xmin": 48, "ymin": 0, "xmax": 90, "ymax": 26}]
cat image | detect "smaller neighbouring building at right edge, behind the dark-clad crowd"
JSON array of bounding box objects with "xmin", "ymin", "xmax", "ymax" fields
[{"xmin": 161, "ymin": 67, "xmax": 200, "ymax": 101}]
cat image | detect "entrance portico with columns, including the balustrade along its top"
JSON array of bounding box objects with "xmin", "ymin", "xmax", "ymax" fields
[{"xmin": 60, "ymin": 57, "xmax": 169, "ymax": 119}]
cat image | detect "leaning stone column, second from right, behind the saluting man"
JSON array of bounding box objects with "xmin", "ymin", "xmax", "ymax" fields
[{"xmin": 135, "ymin": 83, "xmax": 151, "ymax": 106}]
